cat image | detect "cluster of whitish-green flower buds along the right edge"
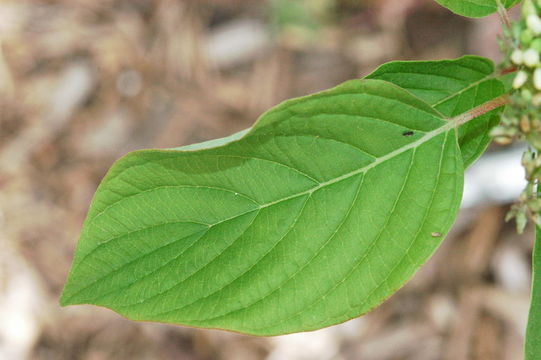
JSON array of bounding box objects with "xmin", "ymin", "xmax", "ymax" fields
[{"xmin": 496, "ymin": 0, "xmax": 541, "ymax": 232}]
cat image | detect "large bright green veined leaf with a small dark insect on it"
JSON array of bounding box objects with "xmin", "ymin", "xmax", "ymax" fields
[{"xmin": 61, "ymin": 80, "xmax": 463, "ymax": 335}]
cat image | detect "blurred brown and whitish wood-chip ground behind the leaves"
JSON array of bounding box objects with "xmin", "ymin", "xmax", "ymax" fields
[{"xmin": 0, "ymin": 0, "xmax": 533, "ymax": 360}]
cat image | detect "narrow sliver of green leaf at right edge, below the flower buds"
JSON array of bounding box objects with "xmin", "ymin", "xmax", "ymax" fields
[{"xmin": 525, "ymin": 227, "xmax": 541, "ymax": 360}]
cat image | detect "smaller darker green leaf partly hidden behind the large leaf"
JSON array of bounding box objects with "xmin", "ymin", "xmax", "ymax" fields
[{"xmin": 366, "ymin": 56, "xmax": 506, "ymax": 167}]
